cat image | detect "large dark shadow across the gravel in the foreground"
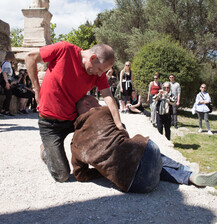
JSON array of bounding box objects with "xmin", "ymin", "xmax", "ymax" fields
[{"xmin": 0, "ymin": 180, "xmax": 215, "ymax": 224}]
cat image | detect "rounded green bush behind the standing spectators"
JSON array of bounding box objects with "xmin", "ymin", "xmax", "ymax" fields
[{"xmin": 132, "ymin": 37, "xmax": 200, "ymax": 106}]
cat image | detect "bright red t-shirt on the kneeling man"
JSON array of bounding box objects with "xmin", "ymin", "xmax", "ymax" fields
[{"xmin": 38, "ymin": 41, "xmax": 109, "ymax": 120}]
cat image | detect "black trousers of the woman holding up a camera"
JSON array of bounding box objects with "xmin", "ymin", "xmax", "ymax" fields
[{"xmin": 157, "ymin": 113, "xmax": 171, "ymax": 140}]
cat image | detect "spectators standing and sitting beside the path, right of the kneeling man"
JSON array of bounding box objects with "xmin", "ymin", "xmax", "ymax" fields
[{"xmin": 107, "ymin": 64, "xmax": 213, "ymax": 140}]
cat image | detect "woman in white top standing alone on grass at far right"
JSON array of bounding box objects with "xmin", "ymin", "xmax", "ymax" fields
[{"xmin": 195, "ymin": 83, "xmax": 213, "ymax": 135}]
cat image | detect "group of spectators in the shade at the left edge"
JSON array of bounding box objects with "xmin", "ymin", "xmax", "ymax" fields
[{"xmin": 0, "ymin": 52, "xmax": 37, "ymax": 116}]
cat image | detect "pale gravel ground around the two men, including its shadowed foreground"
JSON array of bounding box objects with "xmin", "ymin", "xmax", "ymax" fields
[{"xmin": 0, "ymin": 103, "xmax": 217, "ymax": 224}]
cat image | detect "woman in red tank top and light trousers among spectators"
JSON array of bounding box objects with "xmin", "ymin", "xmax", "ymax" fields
[{"xmin": 147, "ymin": 72, "xmax": 162, "ymax": 127}]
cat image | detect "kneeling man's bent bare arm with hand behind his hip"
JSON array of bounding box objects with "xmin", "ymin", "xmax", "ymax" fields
[{"xmin": 25, "ymin": 49, "xmax": 42, "ymax": 104}]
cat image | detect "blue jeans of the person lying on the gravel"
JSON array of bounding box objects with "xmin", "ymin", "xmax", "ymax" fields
[{"xmin": 129, "ymin": 140, "xmax": 191, "ymax": 193}]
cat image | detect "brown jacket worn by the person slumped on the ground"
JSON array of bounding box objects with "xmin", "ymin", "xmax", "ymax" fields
[{"xmin": 71, "ymin": 107, "xmax": 149, "ymax": 192}]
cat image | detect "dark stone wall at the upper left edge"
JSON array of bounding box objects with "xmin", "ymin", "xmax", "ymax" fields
[{"xmin": 0, "ymin": 20, "xmax": 11, "ymax": 62}]
